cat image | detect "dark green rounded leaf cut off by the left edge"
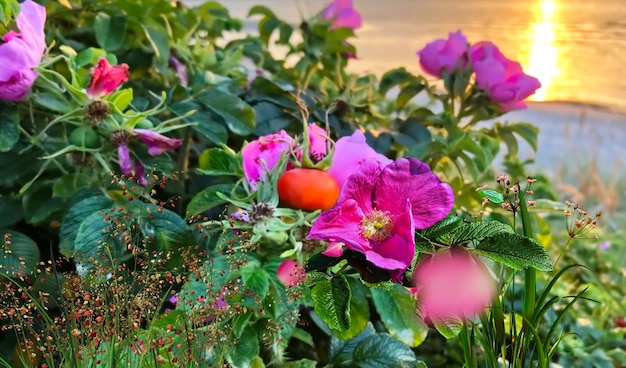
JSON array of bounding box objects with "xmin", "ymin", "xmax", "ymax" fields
[{"xmin": 0, "ymin": 229, "xmax": 39, "ymax": 277}]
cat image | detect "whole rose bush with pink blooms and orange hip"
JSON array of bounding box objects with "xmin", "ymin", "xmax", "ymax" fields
[{"xmin": 0, "ymin": 0, "xmax": 595, "ymax": 367}]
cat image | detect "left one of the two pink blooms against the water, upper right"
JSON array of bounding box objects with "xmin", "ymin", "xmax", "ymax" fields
[{"xmin": 417, "ymin": 31, "xmax": 469, "ymax": 78}]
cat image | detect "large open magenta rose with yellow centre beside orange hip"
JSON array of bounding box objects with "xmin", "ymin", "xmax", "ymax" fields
[{"xmin": 308, "ymin": 158, "xmax": 454, "ymax": 281}]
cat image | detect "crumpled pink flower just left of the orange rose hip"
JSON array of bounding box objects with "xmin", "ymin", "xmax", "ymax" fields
[{"xmin": 241, "ymin": 130, "xmax": 294, "ymax": 189}]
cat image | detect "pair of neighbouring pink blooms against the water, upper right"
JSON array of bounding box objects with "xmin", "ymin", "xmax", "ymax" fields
[{"xmin": 417, "ymin": 31, "xmax": 541, "ymax": 112}]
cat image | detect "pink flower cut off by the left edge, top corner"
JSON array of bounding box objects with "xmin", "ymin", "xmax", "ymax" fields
[{"xmin": 0, "ymin": 0, "xmax": 46, "ymax": 100}]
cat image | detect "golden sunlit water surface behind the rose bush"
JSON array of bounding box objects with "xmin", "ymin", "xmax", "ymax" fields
[{"xmin": 186, "ymin": 0, "xmax": 626, "ymax": 112}]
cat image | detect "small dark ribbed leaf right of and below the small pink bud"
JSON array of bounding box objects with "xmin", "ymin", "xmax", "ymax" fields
[{"xmin": 311, "ymin": 275, "xmax": 352, "ymax": 331}]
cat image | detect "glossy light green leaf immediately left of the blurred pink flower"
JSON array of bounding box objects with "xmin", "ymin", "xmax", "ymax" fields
[{"xmin": 371, "ymin": 284, "xmax": 428, "ymax": 347}]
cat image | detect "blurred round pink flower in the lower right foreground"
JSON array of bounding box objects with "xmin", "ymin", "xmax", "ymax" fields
[{"xmin": 413, "ymin": 253, "xmax": 495, "ymax": 320}]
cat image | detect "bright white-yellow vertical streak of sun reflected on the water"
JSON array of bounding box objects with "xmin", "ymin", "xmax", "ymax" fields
[{"xmin": 525, "ymin": 0, "xmax": 560, "ymax": 101}]
